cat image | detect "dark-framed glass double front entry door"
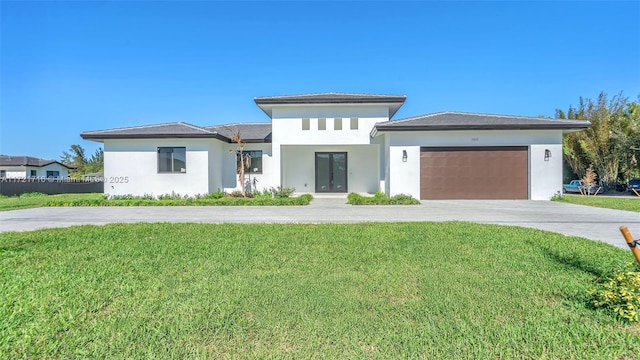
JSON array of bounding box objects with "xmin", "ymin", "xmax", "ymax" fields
[{"xmin": 316, "ymin": 153, "xmax": 347, "ymax": 193}]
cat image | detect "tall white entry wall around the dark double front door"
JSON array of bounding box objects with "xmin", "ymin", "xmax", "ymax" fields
[{"xmin": 271, "ymin": 104, "xmax": 389, "ymax": 192}]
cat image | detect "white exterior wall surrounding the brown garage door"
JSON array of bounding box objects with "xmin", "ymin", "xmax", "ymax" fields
[{"xmin": 381, "ymin": 130, "xmax": 562, "ymax": 200}]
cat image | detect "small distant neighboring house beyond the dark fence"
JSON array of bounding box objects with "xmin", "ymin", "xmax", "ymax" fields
[{"xmin": 0, "ymin": 155, "xmax": 75, "ymax": 179}]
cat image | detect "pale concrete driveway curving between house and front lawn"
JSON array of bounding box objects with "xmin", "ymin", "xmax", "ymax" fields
[{"xmin": 0, "ymin": 198, "xmax": 640, "ymax": 249}]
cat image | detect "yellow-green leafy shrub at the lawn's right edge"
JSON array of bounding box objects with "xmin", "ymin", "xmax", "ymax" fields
[{"xmin": 590, "ymin": 263, "xmax": 640, "ymax": 322}]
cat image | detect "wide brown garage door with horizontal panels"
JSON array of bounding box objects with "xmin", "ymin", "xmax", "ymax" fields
[{"xmin": 420, "ymin": 146, "xmax": 528, "ymax": 199}]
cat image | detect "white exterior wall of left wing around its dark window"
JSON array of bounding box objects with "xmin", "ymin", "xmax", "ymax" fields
[{"xmin": 104, "ymin": 139, "xmax": 218, "ymax": 196}]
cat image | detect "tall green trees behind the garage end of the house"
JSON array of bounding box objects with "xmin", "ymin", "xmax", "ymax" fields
[{"xmin": 556, "ymin": 92, "xmax": 640, "ymax": 186}]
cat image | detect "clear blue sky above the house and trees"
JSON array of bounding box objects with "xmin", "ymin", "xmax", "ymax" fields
[{"xmin": 0, "ymin": 1, "xmax": 640, "ymax": 159}]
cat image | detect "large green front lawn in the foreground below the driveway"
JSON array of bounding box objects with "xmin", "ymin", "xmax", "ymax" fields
[{"xmin": 0, "ymin": 223, "xmax": 640, "ymax": 359}]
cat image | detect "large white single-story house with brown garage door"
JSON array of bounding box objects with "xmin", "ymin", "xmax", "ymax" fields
[{"xmin": 81, "ymin": 93, "xmax": 589, "ymax": 200}]
